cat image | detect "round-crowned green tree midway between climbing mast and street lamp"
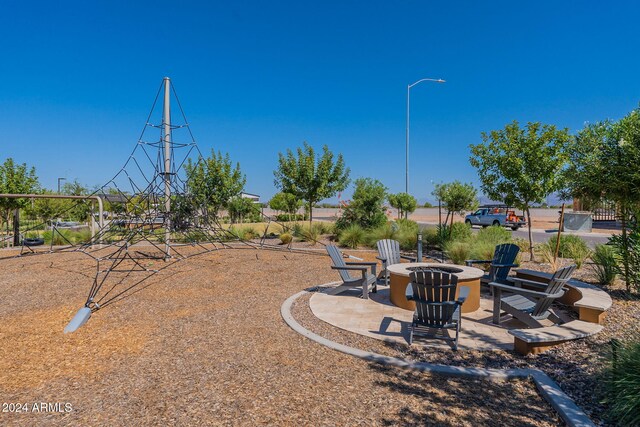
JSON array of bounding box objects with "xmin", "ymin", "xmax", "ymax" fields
[{"xmin": 273, "ymin": 142, "xmax": 350, "ymax": 223}]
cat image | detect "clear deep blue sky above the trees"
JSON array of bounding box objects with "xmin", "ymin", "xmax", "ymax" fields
[{"xmin": 0, "ymin": 1, "xmax": 640, "ymax": 204}]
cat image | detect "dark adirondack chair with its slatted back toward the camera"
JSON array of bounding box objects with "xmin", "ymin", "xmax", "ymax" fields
[{"xmin": 406, "ymin": 269, "xmax": 469, "ymax": 350}]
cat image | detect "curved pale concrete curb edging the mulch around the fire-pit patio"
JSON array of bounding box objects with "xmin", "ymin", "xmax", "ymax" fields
[{"xmin": 280, "ymin": 282, "xmax": 594, "ymax": 427}]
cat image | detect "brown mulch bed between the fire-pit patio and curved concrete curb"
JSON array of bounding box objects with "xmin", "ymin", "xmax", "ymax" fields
[{"xmin": 294, "ymin": 260, "xmax": 640, "ymax": 425}]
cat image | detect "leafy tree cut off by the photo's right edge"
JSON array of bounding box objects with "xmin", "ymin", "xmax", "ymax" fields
[{"xmin": 565, "ymin": 109, "xmax": 640, "ymax": 290}]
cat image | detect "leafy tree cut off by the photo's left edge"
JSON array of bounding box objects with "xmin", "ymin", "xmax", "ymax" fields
[{"xmin": 0, "ymin": 157, "xmax": 40, "ymax": 242}]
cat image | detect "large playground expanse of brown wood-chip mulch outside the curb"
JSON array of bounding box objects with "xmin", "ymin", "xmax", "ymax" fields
[{"xmin": 0, "ymin": 249, "xmax": 559, "ymax": 426}]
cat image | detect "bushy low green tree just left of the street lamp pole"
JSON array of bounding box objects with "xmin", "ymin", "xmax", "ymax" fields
[{"xmin": 336, "ymin": 178, "xmax": 387, "ymax": 229}]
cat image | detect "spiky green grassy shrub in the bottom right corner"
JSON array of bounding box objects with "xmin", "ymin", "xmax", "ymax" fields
[{"xmin": 607, "ymin": 336, "xmax": 640, "ymax": 426}]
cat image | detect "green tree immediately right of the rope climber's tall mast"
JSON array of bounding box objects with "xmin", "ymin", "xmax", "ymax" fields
[{"xmin": 185, "ymin": 150, "xmax": 247, "ymax": 216}]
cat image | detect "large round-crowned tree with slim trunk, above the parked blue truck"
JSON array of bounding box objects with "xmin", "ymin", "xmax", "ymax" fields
[{"xmin": 470, "ymin": 121, "xmax": 571, "ymax": 260}]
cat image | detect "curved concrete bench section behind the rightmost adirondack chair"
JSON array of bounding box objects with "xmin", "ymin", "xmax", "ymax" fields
[{"xmin": 515, "ymin": 268, "xmax": 613, "ymax": 324}]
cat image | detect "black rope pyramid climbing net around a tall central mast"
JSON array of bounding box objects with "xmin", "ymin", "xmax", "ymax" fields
[{"xmin": 12, "ymin": 82, "xmax": 328, "ymax": 312}]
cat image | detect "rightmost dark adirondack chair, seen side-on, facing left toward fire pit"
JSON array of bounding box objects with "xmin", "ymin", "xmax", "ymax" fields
[{"xmin": 489, "ymin": 265, "xmax": 576, "ymax": 328}]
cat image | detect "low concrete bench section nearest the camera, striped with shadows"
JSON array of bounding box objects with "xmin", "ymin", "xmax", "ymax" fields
[{"xmin": 509, "ymin": 320, "xmax": 603, "ymax": 356}]
